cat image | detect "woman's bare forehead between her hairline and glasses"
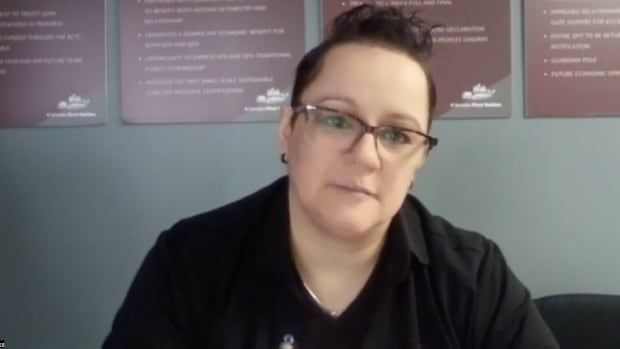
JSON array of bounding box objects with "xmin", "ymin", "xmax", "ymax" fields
[{"xmin": 302, "ymin": 43, "xmax": 429, "ymax": 127}]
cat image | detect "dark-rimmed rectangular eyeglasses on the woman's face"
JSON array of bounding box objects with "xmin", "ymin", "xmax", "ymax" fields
[{"xmin": 293, "ymin": 104, "xmax": 439, "ymax": 159}]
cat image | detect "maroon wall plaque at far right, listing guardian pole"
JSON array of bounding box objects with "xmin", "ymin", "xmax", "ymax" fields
[{"xmin": 524, "ymin": 0, "xmax": 620, "ymax": 117}]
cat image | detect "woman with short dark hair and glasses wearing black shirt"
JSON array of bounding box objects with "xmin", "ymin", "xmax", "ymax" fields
[{"xmin": 104, "ymin": 5, "xmax": 558, "ymax": 349}]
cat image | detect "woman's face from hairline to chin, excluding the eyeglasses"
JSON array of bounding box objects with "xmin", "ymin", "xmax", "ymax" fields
[{"xmin": 279, "ymin": 43, "xmax": 429, "ymax": 239}]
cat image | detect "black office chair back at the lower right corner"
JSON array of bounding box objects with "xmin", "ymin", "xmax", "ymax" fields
[{"xmin": 534, "ymin": 294, "xmax": 620, "ymax": 349}]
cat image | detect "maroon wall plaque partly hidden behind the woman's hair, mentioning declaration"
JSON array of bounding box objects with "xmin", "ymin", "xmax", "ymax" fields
[{"xmin": 322, "ymin": 0, "xmax": 512, "ymax": 118}]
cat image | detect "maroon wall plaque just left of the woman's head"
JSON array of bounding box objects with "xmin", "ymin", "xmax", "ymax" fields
[{"xmin": 120, "ymin": 0, "xmax": 305, "ymax": 123}]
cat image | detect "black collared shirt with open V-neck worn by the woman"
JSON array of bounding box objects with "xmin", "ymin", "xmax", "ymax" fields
[{"xmin": 103, "ymin": 177, "xmax": 559, "ymax": 349}]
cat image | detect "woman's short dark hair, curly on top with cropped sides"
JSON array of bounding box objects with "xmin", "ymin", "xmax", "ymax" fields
[{"xmin": 291, "ymin": 4, "xmax": 437, "ymax": 129}]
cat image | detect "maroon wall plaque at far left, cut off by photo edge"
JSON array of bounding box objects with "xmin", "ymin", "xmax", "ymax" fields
[{"xmin": 0, "ymin": 0, "xmax": 106, "ymax": 127}]
